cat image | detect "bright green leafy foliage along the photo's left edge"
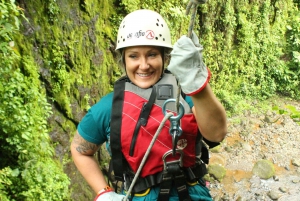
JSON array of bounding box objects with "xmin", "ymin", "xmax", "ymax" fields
[{"xmin": 0, "ymin": 1, "xmax": 69, "ymax": 201}]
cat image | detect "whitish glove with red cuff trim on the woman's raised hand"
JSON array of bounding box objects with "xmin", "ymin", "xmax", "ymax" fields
[{"xmin": 168, "ymin": 33, "xmax": 210, "ymax": 95}]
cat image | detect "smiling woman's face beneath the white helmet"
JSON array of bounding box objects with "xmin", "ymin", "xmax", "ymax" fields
[{"xmin": 124, "ymin": 46, "xmax": 163, "ymax": 89}]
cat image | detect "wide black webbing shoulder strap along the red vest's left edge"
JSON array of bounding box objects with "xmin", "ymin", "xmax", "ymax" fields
[{"xmin": 110, "ymin": 77, "xmax": 127, "ymax": 181}]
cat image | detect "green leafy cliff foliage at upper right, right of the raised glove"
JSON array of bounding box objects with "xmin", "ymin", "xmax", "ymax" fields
[{"xmin": 199, "ymin": 1, "xmax": 299, "ymax": 103}]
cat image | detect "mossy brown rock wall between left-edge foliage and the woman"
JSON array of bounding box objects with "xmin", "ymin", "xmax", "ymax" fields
[{"xmin": 17, "ymin": 0, "xmax": 119, "ymax": 200}]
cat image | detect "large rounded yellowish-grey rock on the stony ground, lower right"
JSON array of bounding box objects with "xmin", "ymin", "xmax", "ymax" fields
[{"xmin": 252, "ymin": 160, "xmax": 275, "ymax": 179}]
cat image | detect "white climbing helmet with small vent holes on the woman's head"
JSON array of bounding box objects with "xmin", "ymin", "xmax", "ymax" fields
[{"xmin": 116, "ymin": 9, "xmax": 172, "ymax": 50}]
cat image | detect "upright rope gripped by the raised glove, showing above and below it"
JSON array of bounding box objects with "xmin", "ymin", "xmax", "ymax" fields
[{"xmin": 176, "ymin": 0, "xmax": 206, "ymax": 113}]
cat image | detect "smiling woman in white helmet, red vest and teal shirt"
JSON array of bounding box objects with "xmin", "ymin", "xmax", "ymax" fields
[{"xmin": 71, "ymin": 10, "xmax": 227, "ymax": 201}]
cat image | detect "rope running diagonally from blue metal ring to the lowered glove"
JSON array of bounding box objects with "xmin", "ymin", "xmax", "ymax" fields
[{"xmin": 123, "ymin": 112, "xmax": 173, "ymax": 200}]
